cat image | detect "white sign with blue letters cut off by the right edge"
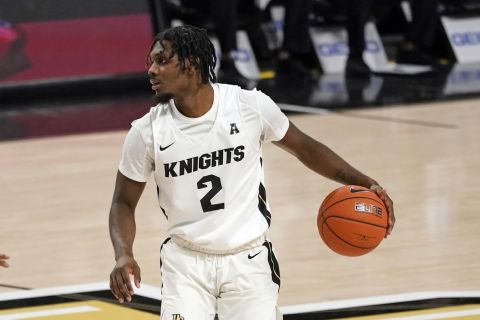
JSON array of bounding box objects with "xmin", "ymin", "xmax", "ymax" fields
[{"xmin": 442, "ymin": 17, "xmax": 480, "ymax": 63}]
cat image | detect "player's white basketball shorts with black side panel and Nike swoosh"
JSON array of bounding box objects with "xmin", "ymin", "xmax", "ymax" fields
[{"xmin": 160, "ymin": 239, "xmax": 282, "ymax": 320}]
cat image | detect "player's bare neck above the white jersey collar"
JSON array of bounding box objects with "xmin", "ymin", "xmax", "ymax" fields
[{"xmin": 175, "ymin": 83, "xmax": 214, "ymax": 118}]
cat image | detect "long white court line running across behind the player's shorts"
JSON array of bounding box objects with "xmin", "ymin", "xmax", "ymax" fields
[{"xmin": 0, "ymin": 282, "xmax": 480, "ymax": 315}]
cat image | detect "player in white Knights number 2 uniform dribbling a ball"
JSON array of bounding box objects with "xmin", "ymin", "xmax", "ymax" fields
[{"xmin": 109, "ymin": 26, "xmax": 394, "ymax": 320}]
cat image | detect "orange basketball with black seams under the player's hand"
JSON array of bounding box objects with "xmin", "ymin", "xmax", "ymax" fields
[{"xmin": 317, "ymin": 185, "xmax": 388, "ymax": 257}]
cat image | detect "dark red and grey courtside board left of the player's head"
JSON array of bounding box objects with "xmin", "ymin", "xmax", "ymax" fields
[{"xmin": 0, "ymin": 0, "xmax": 154, "ymax": 89}]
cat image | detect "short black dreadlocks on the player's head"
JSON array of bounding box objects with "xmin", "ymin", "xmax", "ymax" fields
[{"xmin": 150, "ymin": 25, "xmax": 217, "ymax": 83}]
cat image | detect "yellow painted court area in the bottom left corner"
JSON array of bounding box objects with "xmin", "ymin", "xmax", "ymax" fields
[{"xmin": 0, "ymin": 300, "xmax": 159, "ymax": 320}]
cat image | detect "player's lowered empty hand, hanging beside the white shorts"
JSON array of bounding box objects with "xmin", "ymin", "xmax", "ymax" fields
[{"xmin": 110, "ymin": 256, "xmax": 141, "ymax": 303}]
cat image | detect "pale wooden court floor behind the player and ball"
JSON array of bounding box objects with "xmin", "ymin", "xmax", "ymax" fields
[{"xmin": 0, "ymin": 100, "xmax": 480, "ymax": 306}]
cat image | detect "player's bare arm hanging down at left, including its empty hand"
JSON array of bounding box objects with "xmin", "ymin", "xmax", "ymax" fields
[{"xmin": 109, "ymin": 171, "xmax": 146, "ymax": 303}]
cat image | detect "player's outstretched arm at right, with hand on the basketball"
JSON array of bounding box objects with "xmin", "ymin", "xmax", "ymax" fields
[{"xmin": 274, "ymin": 122, "xmax": 395, "ymax": 234}]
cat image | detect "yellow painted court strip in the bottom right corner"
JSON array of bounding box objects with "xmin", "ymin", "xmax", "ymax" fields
[{"xmin": 342, "ymin": 304, "xmax": 480, "ymax": 320}]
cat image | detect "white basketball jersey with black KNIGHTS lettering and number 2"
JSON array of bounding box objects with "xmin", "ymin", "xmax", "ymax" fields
[{"xmin": 120, "ymin": 84, "xmax": 288, "ymax": 251}]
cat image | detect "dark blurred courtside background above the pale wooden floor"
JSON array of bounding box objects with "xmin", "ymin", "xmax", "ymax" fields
[{"xmin": 0, "ymin": 0, "xmax": 480, "ymax": 130}]
